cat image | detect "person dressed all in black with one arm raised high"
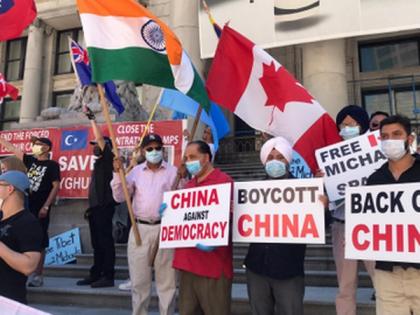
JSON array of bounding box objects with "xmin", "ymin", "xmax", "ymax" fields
[{"xmin": 77, "ymin": 107, "xmax": 116, "ymax": 288}]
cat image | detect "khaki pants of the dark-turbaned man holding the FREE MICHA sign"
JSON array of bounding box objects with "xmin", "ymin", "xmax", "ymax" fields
[{"xmin": 331, "ymin": 222, "xmax": 375, "ymax": 315}]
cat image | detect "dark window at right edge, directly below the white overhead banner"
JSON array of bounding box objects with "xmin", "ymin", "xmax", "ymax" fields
[{"xmin": 359, "ymin": 38, "xmax": 420, "ymax": 72}]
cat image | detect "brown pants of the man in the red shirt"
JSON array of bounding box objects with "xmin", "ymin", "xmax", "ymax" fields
[{"xmin": 179, "ymin": 271, "xmax": 232, "ymax": 315}]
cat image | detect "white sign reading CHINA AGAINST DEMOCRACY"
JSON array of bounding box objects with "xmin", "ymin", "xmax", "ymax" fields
[{"xmin": 159, "ymin": 183, "xmax": 232, "ymax": 248}]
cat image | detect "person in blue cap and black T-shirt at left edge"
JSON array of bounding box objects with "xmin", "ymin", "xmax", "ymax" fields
[{"xmin": 0, "ymin": 170, "xmax": 43, "ymax": 304}]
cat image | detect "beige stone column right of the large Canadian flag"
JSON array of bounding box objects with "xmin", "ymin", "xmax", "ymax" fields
[{"xmin": 302, "ymin": 39, "xmax": 348, "ymax": 118}]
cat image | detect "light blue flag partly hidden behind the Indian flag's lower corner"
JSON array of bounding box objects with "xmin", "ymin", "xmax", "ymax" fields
[{"xmin": 159, "ymin": 89, "xmax": 230, "ymax": 152}]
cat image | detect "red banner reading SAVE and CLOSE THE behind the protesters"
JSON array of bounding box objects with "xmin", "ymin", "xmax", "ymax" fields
[{"xmin": 0, "ymin": 120, "xmax": 186, "ymax": 198}]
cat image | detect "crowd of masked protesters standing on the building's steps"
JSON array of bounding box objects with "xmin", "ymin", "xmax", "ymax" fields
[{"xmin": 0, "ymin": 105, "xmax": 420, "ymax": 315}]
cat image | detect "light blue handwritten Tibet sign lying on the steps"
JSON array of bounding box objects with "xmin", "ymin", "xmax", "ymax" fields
[{"xmin": 44, "ymin": 228, "xmax": 82, "ymax": 266}]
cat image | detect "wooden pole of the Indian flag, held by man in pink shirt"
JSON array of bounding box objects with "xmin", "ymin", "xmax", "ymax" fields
[{"xmin": 97, "ymin": 84, "xmax": 141, "ymax": 246}]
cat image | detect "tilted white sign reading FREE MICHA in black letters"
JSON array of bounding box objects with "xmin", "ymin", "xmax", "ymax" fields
[{"xmin": 315, "ymin": 131, "xmax": 387, "ymax": 201}]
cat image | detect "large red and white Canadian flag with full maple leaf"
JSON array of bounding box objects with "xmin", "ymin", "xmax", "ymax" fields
[{"xmin": 207, "ymin": 25, "xmax": 341, "ymax": 171}]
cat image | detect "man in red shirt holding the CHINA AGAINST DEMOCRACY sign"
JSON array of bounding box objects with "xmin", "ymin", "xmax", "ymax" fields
[{"xmin": 173, "ymin": 141, "xmax": 233, "ymax": 315}]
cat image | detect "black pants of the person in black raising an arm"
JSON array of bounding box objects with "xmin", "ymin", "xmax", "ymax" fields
[{"xmin": 89, "ymin": 205, "xmax": 115, "ymax": 279}]
